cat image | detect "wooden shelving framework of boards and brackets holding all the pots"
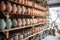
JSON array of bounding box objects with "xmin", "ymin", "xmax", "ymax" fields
[{"xmin": 0, "ymin": 0, "xmax": 49, "ymax": 40}]
